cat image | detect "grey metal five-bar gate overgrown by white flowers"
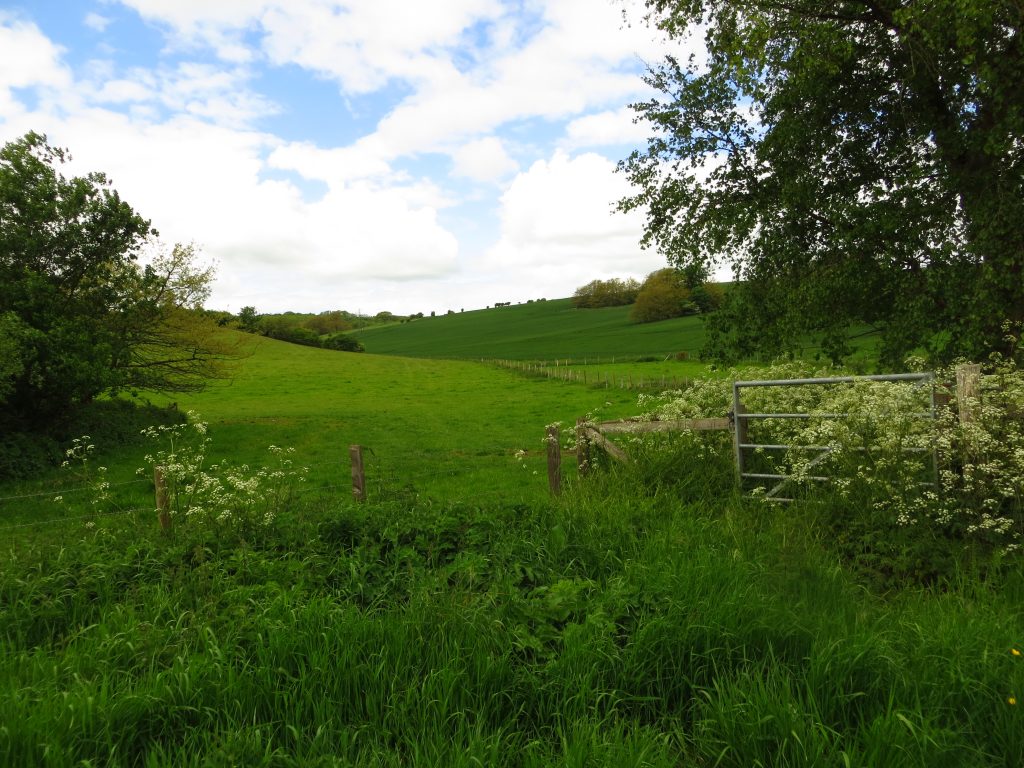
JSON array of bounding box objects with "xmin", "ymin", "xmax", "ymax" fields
[{"xmin": 729, "ymin": 373, "xmax": 938, "ymax": 502}]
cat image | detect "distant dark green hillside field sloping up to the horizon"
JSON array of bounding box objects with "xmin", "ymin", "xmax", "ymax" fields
[{"xmin": 352, "ymin": 299, "xmax": 703, "ymax": 360}]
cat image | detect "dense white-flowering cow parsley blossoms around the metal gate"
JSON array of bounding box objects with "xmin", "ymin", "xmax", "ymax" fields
[{"xmin": 636, "ymin": 337, "xmax": 1024, "ymax": 552}]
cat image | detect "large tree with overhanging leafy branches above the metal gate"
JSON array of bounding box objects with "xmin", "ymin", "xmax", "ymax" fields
[{"xmin": 621, "ymin": 0, "xmax": 1024, "ymax": 365}]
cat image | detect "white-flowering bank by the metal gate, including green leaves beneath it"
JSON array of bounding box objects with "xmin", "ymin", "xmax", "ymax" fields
[{"xmin": 641, "ymin": 354, "xmax": 1024, "ymax": 579}]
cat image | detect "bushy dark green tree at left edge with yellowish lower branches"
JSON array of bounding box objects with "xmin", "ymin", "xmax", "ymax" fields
[{"xmin": 0, "ymin": 133, "xmax": 229, "ymax": 431}]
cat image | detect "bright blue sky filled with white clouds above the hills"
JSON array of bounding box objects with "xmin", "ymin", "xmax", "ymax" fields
[{"xmin": 0, "ymin": 0, "xmax": 704, "ymax": 314}]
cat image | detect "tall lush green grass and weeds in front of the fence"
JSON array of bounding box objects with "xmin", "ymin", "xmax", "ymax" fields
[{"xmin": 0, "ymin": 454, "xmax": 1024, "ymax": 766}]
